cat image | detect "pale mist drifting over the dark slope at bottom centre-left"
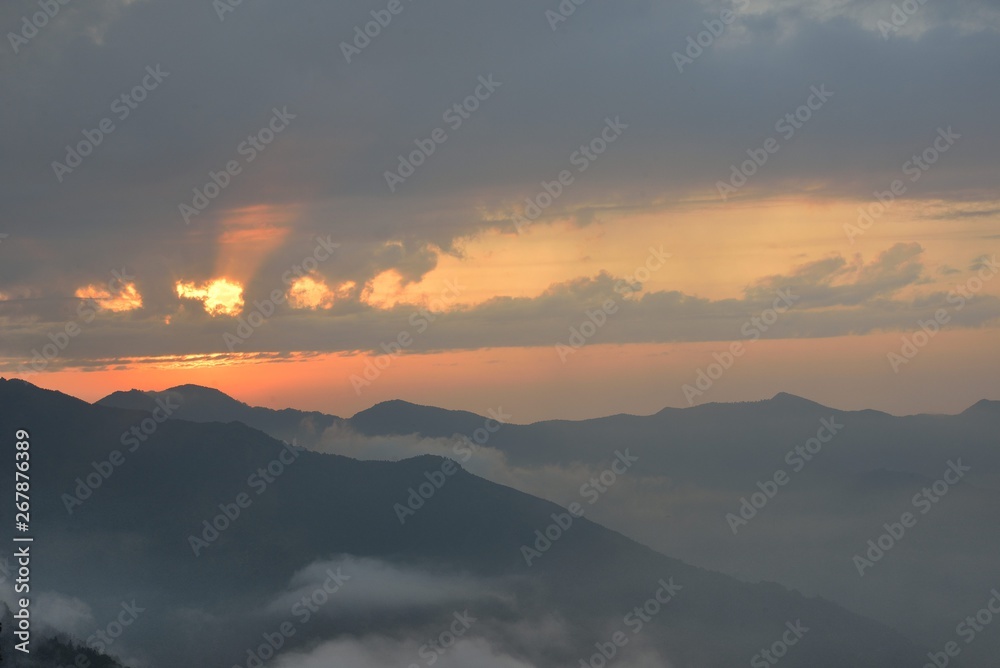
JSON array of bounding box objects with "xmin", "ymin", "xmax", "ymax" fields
[{"xmin": 137, "ymin": 555, "xmax": 608, "ymax": 668}]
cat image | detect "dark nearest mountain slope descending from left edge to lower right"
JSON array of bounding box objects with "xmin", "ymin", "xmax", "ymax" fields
[{"xmin": 0, "ymin": 381, "xmax": 922, "ymax": 668}]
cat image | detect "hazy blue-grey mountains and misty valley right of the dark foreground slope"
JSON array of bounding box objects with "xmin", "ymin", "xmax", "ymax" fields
[{"xmin": 99, "ymin": 386, "xmax": 1000, "ymax": 665}]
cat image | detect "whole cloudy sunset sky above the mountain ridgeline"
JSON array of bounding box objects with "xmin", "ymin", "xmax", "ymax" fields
[{"xmin": 0, "ymin": 0, "xmax": 1000, "ymax": 422}]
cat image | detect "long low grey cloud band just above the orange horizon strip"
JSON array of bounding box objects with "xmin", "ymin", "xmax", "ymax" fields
[{"xmin": 0, "ymin": 243, "xmax": 1000, "ymax": 369}]
